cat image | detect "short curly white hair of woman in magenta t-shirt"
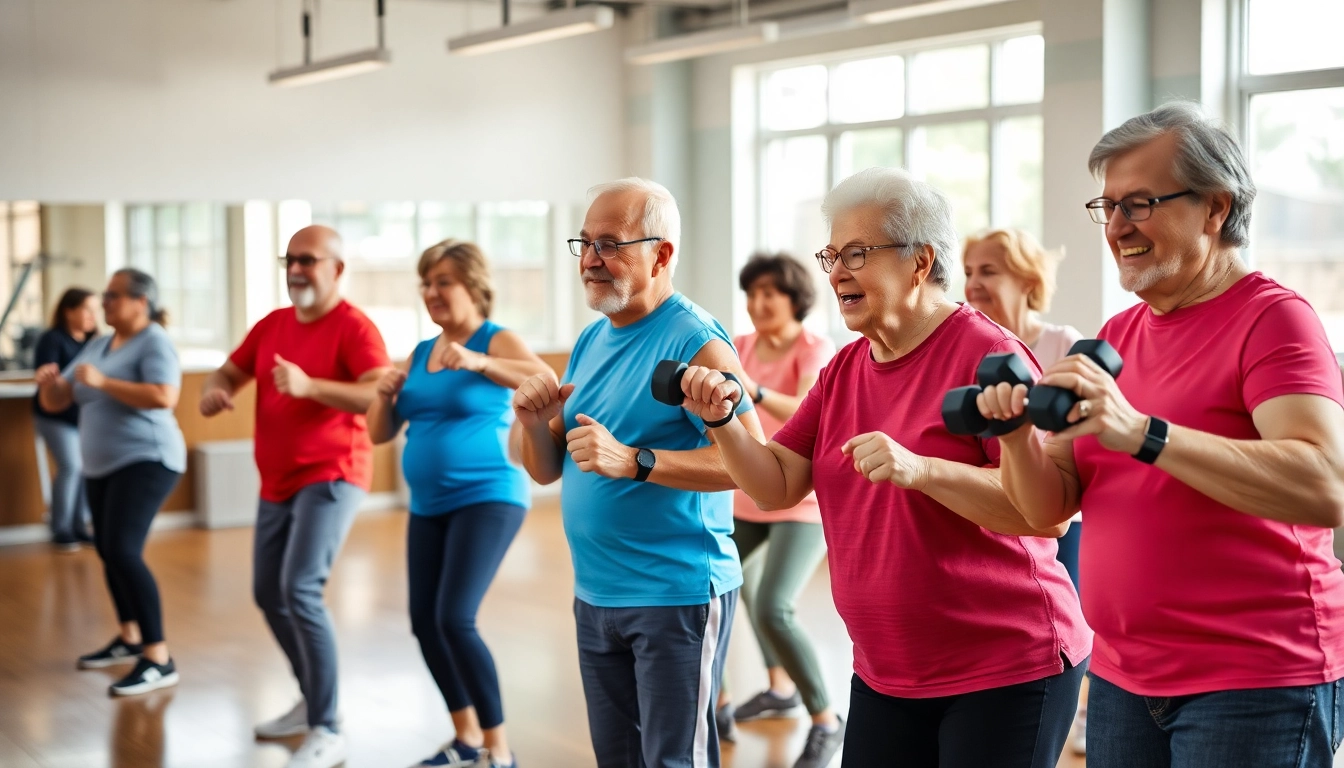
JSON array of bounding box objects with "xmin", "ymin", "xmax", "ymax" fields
[{"xmin": 821, "ymin": 168, "xmax": 961, "ymax": 291}]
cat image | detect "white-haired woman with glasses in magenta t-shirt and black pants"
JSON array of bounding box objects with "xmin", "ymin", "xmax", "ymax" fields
[{"xmin": 683, "ymin": 168, "xmax": 1091, "ymax": 768}]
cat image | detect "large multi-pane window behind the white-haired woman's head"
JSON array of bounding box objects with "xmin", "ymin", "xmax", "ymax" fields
[{"xmin": 757, "ymin": 32, "xmax": 1044, "ymax": 339}]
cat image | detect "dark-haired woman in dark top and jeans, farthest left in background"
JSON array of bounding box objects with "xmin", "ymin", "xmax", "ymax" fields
[{"xmin": 32, "ymin": 288, "xmax": 98, "ymax": 551}]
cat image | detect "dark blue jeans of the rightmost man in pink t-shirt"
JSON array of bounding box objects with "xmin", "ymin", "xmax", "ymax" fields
[{"xmin": 1087, "ymin": 675, "xmax": 1340, "ymax": 768}]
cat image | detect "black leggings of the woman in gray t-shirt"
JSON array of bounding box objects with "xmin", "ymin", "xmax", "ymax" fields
[{"xmin": 85, "ymin": 461, "xmax": 181, "ymax": 644}]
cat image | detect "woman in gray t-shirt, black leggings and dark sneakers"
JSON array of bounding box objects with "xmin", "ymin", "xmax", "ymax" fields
[{"xmin": 36, "ymin": 269, "xmax": 187, "ymax": 695}]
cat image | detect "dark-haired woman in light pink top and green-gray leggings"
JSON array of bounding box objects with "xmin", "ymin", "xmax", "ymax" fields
[{"xmin": 719, "ymin": 254, "xmax": 843, "ymax": 768}]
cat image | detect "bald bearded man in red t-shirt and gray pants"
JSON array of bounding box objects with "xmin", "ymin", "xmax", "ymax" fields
[{"xmin": 200, "ymin": 226, "xmax": 390, "ymax": 768}]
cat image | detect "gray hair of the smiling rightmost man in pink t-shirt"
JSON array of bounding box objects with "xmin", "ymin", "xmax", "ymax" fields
[{"xmin": 1087, "ymin": 101, "xmax": 1255, "ymax": 247}]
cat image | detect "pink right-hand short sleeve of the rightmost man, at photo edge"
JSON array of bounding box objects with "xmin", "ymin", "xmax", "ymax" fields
[{"xmin": 1242, "ymin": 296, "xmax": 1344, "ymax": 413}]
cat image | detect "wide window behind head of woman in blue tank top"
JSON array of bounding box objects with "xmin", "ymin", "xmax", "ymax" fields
[{"xmin": 312, "ymin": 202, "xmax": 559, "ymax": 358}]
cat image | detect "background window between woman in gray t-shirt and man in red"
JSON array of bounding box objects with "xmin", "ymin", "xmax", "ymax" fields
[{"xmin": 126, "ymin": 203, "xmax": 228, "ymax": 359}]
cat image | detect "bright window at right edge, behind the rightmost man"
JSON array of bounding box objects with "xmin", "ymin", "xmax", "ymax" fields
[{"xmin": 1241, "ymin": 0, "xmax": 1344, "ymax": 352}]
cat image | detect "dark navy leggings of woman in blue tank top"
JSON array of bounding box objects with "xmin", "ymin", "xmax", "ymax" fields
[{"xmin": 406, "ymin": 502, "xmax": 527, "ymax": 728}]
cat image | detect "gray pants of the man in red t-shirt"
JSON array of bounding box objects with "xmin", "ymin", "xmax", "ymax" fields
[{"xmin": 253, "ymin": 480, "xmax": 364, "ymax": 730}]
